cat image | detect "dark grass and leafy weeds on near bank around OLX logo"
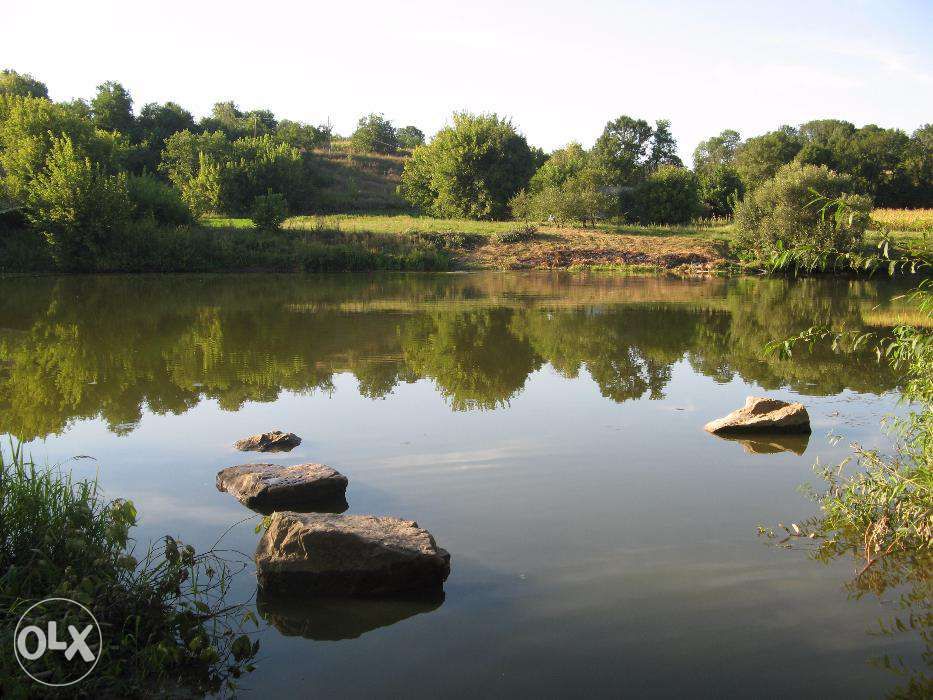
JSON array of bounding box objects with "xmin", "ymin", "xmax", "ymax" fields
[{"xmin": 0, "ymin": 446, "xmax": 259, "ymax": 698}]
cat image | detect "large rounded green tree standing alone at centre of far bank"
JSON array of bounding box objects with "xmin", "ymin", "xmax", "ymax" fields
[{"xmin": 399, "ymin": 112, "xmax": 534, "ymax": 219}]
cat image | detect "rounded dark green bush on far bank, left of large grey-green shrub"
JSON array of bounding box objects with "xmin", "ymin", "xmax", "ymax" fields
[{"xmin": 630, "ymin": 165, "xmax": 701, "ymax": 224}]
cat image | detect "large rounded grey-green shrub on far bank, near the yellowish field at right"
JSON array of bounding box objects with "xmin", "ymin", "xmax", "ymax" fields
[{"xmin": 735, "ymin": 163, "xmax": 871, "ymax": 259}]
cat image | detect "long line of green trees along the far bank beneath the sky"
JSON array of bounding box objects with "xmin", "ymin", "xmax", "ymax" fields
[{"xmin": 0, "ymin": 70, "xmax": 933, "ymax": 269}]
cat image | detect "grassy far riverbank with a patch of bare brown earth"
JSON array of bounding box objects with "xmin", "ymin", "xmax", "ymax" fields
[{"xmin": 0, "ymin": 214, "xmax": 933, "ymax": 276}]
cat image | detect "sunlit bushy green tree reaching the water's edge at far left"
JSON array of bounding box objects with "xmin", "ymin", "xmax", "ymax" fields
[{"xmin": 27, "ymin": 136, "xmax": 131, "ymax": 270}]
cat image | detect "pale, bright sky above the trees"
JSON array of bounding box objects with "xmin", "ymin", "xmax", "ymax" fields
[{"xmin": 7, "ymin": 0, "xmax": 933, "ymax": 163}]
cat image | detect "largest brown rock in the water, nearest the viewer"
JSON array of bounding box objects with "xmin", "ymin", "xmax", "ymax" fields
[{"xmin": 256, "ymin": 511, "xmax": 450, "ymax": 596}]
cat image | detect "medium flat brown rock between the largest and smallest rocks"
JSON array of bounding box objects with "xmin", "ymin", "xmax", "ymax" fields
[{"xmin": 217, "ymin": 464, "xmax": 347, "ymax": 512}]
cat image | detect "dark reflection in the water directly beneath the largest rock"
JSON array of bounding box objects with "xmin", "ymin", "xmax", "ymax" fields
[{"xmin": 256, "ymin": 587, "xmax": 444, "ymax": 642}]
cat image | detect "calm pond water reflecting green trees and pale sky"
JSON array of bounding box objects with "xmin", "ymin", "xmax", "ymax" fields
[{"xmin": 0, "ymin": 273, "xmax": 919, "ymax": 697}]
